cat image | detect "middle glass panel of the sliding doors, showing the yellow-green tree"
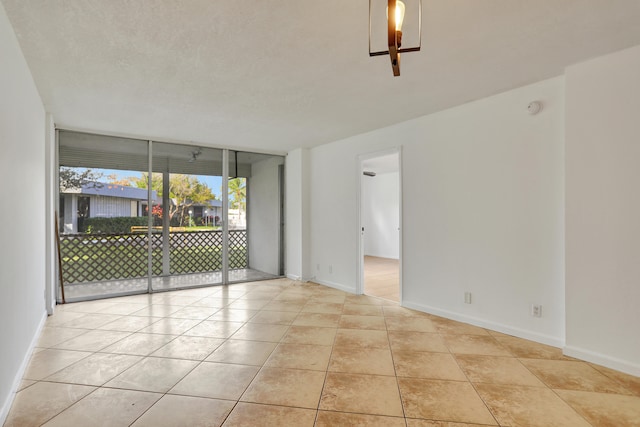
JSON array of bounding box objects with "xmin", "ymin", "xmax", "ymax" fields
[{"xmin": 152, "ymin": 142, "xmax": 223, "ymax": 290}]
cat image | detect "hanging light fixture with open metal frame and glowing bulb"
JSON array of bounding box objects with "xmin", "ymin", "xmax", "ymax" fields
[{"xmin": 369, "ymin": 0, "xmax": 422, "ymax": 77}]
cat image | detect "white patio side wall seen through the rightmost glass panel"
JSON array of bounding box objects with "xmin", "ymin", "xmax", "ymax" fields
[{"xmin": 247, "ymin": 157, "xmax": 284, "ymax": 275}]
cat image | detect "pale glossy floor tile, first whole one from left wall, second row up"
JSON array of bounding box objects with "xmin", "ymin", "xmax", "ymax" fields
[{"xmin": 46, "ymin": 353, "xmax": 142, "ymax": 386}]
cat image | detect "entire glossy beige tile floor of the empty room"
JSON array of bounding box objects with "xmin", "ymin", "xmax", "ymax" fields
[{"xmin": 5, "ymin": 279, "xmax": 640, "ymax": 427}]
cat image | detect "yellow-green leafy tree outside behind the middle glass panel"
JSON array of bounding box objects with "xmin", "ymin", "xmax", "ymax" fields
[{"xmin": 132, "ymin": 173, "xmax": 215, "ymax": 225}]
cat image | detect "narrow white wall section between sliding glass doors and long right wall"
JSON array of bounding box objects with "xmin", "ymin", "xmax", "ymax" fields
[{"xmin": 285, "ymin": 148, "xmax": 313, "ymax": 281}]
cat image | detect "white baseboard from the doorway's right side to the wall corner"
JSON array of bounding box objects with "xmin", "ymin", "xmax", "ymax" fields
[{"xmin": 402, "ymin": 301, "xmax": 565, "ymax": 348}]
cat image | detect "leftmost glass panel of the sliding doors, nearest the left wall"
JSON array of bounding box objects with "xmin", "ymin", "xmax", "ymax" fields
[{"xmin": 58, "ymin": 131, "xmax": 151, "ymax": 301}]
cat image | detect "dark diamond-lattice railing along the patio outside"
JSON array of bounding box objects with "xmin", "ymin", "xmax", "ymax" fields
[{"xmin": 60, "ymin": 230, "xmax": 249, "ymax": 285}]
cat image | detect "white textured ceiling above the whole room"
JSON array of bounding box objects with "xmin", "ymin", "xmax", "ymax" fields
[{"xmin": 1, "ymin": 0, "xmax": 640, "ymax": 153}]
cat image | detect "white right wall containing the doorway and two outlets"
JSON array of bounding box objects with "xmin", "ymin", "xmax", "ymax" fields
[{"xmin": 310, "ymin": 77, "xmax": 564, "ymax": 346}]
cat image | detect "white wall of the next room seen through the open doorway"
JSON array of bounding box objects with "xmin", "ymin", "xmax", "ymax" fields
[{"xmin": 362, "ymin": 172, "xmax": 400, "ymax": 259}]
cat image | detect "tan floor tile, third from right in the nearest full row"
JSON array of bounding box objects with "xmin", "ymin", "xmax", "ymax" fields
[{"xmin": 398, "ymin": 378, "xmax": 497, "ymax": 425}]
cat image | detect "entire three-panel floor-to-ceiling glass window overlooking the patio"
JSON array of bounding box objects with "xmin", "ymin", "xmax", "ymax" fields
[{"xmin": 58, "ymin": 131, "xmax": 284, "ymax": 301}]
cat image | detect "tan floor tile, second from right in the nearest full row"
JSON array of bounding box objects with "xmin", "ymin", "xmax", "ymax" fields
[{"xmin": 476, "ymin": 384, "xmax": 589, "ymax": 427}]
